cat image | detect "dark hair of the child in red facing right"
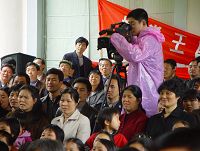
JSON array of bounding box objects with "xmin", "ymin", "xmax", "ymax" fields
[{"xmin": 97, "ymin": 107, "xmax": 119, "ymax": 129}]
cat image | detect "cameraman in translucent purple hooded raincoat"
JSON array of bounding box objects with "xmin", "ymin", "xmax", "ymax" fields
[{"xmin": 111, "ymin": 8, "xmax": 165, "ymax": 116}]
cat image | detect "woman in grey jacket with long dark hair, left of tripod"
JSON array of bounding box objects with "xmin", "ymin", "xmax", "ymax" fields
[{"xmin": 87, "ymin": 70, "xmax": 104, "ymax": 107}]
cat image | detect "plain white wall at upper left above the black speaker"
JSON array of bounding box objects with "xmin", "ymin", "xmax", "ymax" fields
[{"xmin": 0, "ymin": 0, "xmax": 23, "ymax": 57}]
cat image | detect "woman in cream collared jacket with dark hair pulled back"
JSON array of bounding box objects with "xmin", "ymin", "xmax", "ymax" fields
[{"xmin": 51, "ymin": 88, "xmax": 91, "ymax": 143}]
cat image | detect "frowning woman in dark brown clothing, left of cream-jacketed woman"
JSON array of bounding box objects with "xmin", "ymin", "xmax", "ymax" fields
[{"xmin": 13, "ymin": 85, "xmax": 48, "ymax": 140}]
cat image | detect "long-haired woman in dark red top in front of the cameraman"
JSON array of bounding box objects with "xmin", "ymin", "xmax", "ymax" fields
[{"xmin": 119, "ymin": 85, "xmax": 147, "ymax": 141}]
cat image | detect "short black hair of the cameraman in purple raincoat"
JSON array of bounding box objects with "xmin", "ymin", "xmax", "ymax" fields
[{"xmin": 127, "ymin": 8, "xmax": 148, "ymax": 26}]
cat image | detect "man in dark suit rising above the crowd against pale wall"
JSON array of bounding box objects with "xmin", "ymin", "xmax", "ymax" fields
[{"xmin": 63, "ymin": 37, "xmax": 92, "ymax": 78}]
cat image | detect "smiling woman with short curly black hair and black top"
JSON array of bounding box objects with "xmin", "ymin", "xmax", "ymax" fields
[{"xmin": 146, "ymin": 79, "xmax": 195, "ymax": 139}]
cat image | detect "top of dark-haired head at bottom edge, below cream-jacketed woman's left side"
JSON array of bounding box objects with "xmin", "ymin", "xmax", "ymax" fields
[{"xmin": 26, "ymin": 139, "xmax": 65, "ymax": 151}]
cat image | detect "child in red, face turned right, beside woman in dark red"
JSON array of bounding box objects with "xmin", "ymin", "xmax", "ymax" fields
[{"xmin": 86, "ymin": 108, "xmax": 127, "ymax": 149}]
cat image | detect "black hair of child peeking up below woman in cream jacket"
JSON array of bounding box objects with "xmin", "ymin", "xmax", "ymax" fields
[{"xmin": 43, "ymin": 124, "xmax": 65, "ymax": 142}]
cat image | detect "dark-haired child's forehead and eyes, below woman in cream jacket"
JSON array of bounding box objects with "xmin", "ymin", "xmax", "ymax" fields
[{"xmin": 40, "ymin": 124, "xmax": 65, "ymax": 142}]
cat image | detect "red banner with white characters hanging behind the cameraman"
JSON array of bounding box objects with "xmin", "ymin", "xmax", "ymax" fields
[{"xmin": 98, "ymin": 0, "xmax": 200, "ymax": 79}]
